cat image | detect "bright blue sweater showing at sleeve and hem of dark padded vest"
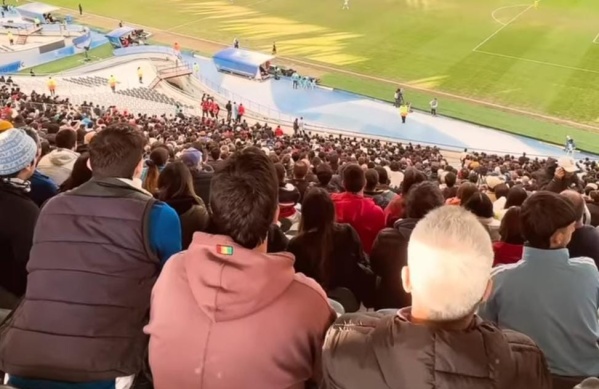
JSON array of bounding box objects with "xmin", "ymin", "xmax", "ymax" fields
[{"xmin": 9, "ymin": 202, "xmax": 181, "ymax": 389}]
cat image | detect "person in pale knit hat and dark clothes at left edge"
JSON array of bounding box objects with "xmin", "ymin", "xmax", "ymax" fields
[{"xmin": 0, "ymin": 129, "xmax": 39, "ymax": 309}]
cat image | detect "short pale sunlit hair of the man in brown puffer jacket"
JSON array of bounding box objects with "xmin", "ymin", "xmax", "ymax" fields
[{"xmin": 408, "ymin": 206, "xmax": 493, "ymax": 321}]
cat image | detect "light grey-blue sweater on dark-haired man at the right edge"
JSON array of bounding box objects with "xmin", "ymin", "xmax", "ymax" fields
[{"xmin": 479, "ymin": 247, "xmax": 599, "ymax": 377}]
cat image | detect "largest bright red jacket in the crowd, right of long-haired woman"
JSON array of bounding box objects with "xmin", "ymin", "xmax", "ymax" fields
[{"xmin": 331, "ymin": 192, "xmax": 385, "ymax": 254}]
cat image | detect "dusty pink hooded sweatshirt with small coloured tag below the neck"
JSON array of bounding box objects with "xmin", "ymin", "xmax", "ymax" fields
[{"xmin": 145, "ymin": 233, "xmax": 335, "ymax": 389}]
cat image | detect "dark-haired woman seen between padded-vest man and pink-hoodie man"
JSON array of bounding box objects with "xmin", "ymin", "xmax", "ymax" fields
[{"xmin": 157, "ymin": 161, "xmax": 210, "ymax": 250}]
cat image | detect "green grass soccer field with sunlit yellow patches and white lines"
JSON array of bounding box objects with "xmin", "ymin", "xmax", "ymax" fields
[{"xmin": 41, "ymin": 0, "xmax": 599, "ymax": 143}]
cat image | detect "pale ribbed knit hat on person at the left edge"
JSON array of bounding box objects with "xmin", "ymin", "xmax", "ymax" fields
[{"xmin": 0, "ymin": 128, "xmax": 37, "ymax": 176}]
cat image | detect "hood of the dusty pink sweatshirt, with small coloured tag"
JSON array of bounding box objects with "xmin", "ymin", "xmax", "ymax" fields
[{"xmin": 180, "ymin": 232, "xmax": 295, "ymax": 322}]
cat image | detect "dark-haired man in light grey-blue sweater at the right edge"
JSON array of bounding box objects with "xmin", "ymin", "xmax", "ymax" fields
[{"xmin": 480, "ymin": 191, "xmax": 599, "ymax": 387}]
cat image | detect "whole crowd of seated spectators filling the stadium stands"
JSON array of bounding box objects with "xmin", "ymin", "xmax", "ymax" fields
[{"xmin": 0, "ymin": 83, "xmax": 599, "ymax": 389}]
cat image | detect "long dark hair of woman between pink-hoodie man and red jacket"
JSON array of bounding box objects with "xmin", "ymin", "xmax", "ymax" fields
[{"xmin": 299, "ymin": 187, "xmax": 335, "ymax": 289}]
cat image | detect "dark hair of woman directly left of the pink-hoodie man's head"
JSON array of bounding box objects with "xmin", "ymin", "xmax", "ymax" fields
[{"xmin": 157, "ymin": 161, "xmax": 203, "ymax": 204}]
